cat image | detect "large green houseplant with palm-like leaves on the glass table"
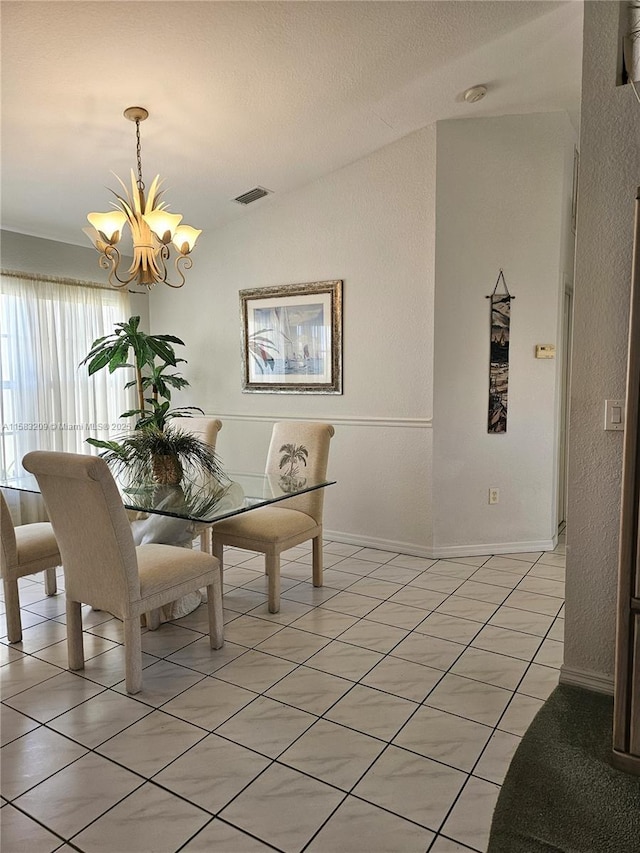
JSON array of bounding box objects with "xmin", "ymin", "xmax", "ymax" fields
[{"xmin": 81, "ymin": 317, "xmax": 224, "ymax": 485}]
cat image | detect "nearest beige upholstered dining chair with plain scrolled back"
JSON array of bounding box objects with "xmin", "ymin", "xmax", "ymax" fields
[{"xmin": 22, "ymin": 450, "xmax": 224, "ymax": 693}]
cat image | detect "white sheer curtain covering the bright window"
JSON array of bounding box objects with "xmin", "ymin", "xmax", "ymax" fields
[{"xmin": 0, "ymin": 271, "xmax": 131, "ymax": 477}]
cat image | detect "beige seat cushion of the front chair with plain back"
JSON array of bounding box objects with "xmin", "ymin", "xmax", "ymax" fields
[{"xmin": 136, "ymin": 544, "xmax": 219, "ymax": 598}]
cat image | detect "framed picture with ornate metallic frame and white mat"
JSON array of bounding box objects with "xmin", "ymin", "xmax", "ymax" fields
[{"xmin": 240, "ymin": 281, "xmax": 342, "ymax": 394}]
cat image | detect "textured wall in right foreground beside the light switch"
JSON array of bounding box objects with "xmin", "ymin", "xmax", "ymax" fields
[{"xmin": 562, "ymin": 2, "xmax": 640, "ymax": 689}]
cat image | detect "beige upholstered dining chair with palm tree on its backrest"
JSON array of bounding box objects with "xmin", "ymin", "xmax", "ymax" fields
[{"xmin": 211, "ymin": 421, "xmax": 334, "ymax": 613}]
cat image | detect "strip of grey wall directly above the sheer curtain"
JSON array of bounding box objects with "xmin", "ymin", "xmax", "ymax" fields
[{"xmin": 0, "ymin": 231, "xmax": 149, "ymax": 327}]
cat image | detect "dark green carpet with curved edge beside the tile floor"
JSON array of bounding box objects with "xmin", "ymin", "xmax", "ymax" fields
[{"xmin": 487, "ymin": 685, "xmax": 640, "ymax": 853}]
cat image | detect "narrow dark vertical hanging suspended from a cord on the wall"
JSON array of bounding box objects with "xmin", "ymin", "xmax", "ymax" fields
[{"xmin": 487, "ymin": 270, "xmax": 515, "ymax": 433}]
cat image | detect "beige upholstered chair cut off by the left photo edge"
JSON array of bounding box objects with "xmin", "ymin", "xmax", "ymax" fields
[{"xmin": 0, "ymin": 492, "xmax": 62, "ymax": 643}]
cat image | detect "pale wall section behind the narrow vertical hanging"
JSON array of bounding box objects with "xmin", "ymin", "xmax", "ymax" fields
[{"xmin": 433, "ymin": 113, "xmax": 575, "ymax": 556}]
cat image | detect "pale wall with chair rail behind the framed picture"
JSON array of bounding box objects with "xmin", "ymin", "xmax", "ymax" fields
[{"xmin": 150, "ymin": 128, "xmax": 435, "ymax": 554}]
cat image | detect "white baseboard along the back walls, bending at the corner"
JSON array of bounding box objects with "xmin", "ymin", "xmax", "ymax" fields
[{"xmin": 323, "ymin": 527, "xmax": 557, "ymax": 560}]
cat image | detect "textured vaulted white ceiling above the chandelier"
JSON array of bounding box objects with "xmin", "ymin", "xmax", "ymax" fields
[{"xmin": 0, "ymin": 0, "xmax": 582, "ymax": 245}]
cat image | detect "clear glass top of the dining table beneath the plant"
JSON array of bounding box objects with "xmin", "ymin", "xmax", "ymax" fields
[{"xmin": 0, "ymin": 472, "xmax": 336, "ymax": 525}]
